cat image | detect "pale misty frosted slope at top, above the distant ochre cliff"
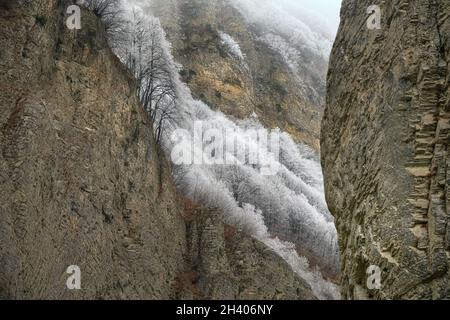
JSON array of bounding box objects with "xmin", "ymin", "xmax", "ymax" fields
[{"xmin": 230, "ymin": 0, "xmax": 339, "ymax": 105}]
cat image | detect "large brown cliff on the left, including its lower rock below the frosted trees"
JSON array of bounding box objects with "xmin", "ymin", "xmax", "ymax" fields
[{"xmin": 0, "ymin": 0, "xmax": 313, "ymax": 299}]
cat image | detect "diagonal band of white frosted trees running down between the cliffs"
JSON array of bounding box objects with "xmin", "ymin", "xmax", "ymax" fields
[{"xmin": 118, "ymin": 1, "xmax": 339, "ymax": 299}]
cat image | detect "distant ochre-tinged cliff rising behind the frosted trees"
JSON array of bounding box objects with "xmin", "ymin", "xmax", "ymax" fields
[{"xmin": 149, "ymin": 0, "xmax": 327, "ymax": 150}]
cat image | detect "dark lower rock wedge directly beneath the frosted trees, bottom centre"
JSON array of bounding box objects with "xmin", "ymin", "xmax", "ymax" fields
[{"xmin": 174, "ymin": 201, "xmax": 316, "ymax": 300}]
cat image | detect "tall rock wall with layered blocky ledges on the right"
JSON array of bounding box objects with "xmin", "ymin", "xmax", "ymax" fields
[{"xmin": 322, "ymin": 0, "xmax": 450, "ymax": 299}]
